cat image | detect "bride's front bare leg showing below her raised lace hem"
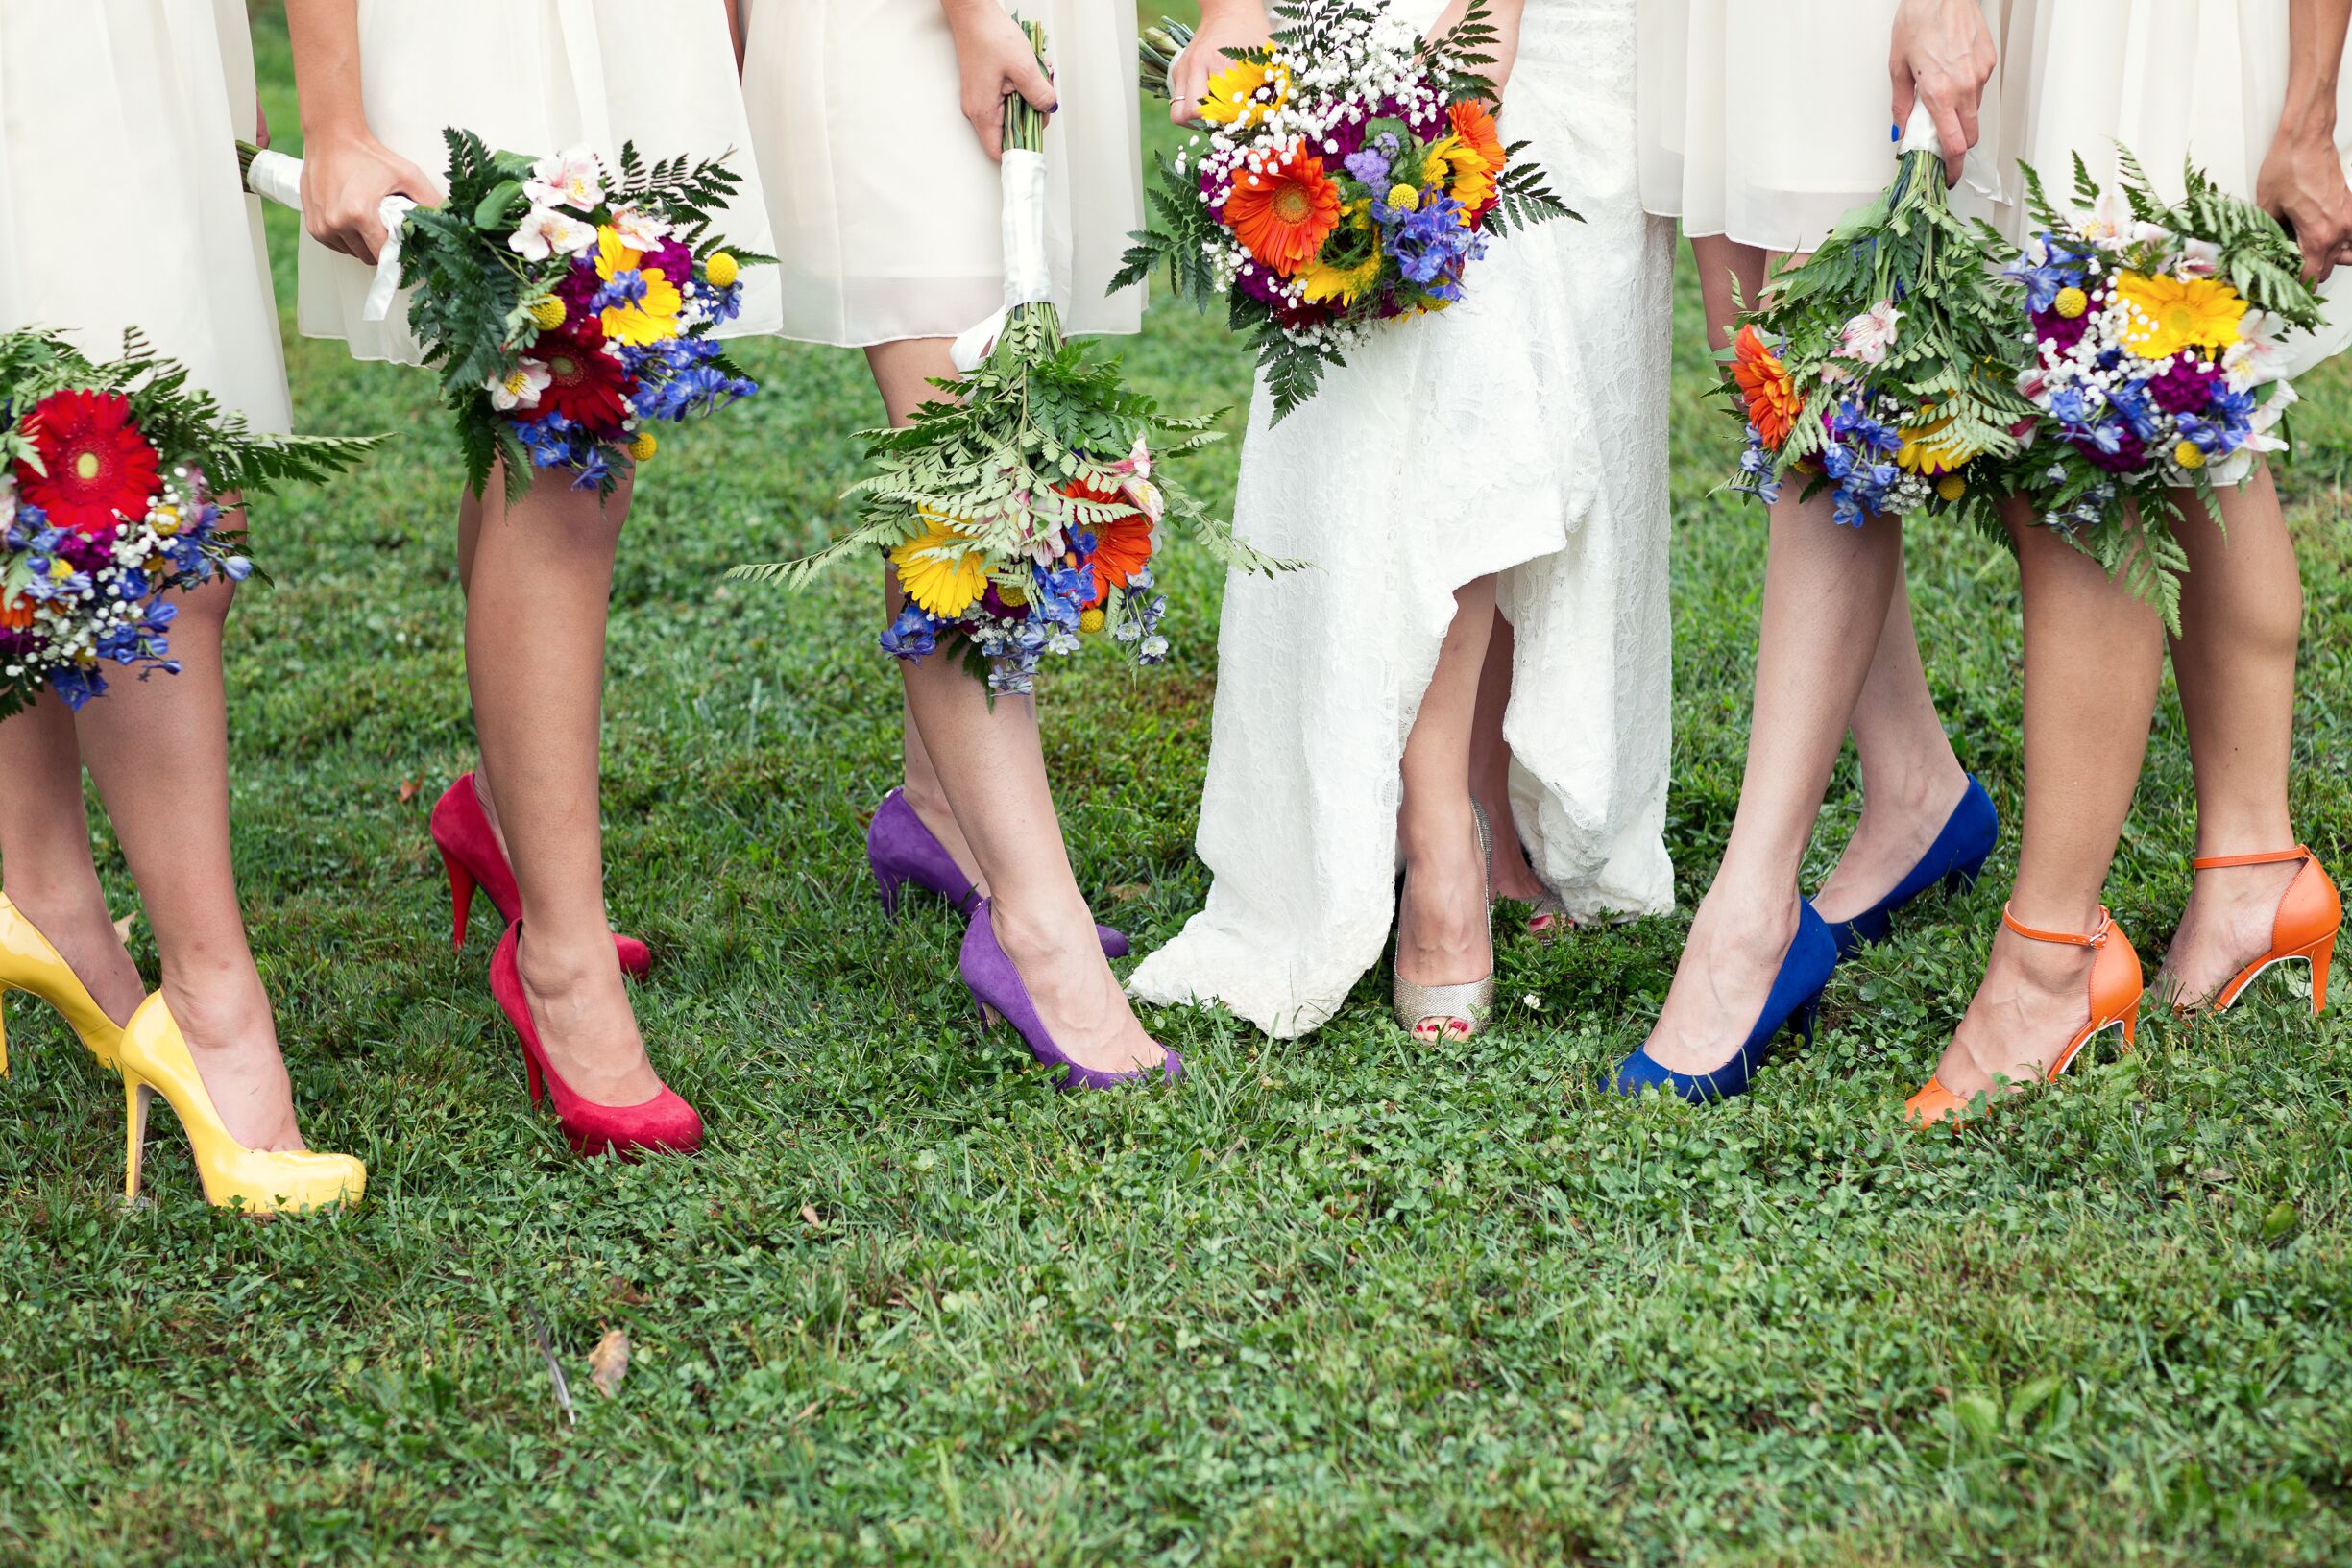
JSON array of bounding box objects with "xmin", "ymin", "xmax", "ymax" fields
[{"xmin": 1397, "ymin": 576, "xmax": 1510, "ymax": 1039}]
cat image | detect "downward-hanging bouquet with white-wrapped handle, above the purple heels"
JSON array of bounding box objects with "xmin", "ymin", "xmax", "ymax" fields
[{"xmin": 729, "ymin": 23, "xmax": 1284, "ymax": 693}]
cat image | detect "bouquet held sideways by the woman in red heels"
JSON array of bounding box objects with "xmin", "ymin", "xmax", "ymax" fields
[{"xmin": 240, "ymin": 140, "xmax": 769, "ymax": 496}]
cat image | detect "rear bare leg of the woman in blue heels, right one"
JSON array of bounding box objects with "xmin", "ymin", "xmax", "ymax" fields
[{"xmin": 1813, "ymin": 576, "xmax": 1969, "ymax": 919}]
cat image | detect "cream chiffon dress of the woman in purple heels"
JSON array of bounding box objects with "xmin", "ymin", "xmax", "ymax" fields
[{"xmin": 743, "ymin": 0, "xmax": 1143, "ymax": 348}]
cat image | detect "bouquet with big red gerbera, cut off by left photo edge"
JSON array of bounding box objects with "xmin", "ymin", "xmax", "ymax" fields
[{"xmin": 0, "ymin": 331, "xmax": 376, "ymax": 717}]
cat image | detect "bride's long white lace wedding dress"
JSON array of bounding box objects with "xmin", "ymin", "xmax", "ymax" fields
[{"xmin": 1129, "ymin": 0, "xmax": 1672, "ymax": 1037}]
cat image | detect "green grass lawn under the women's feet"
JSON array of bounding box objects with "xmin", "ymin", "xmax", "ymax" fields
[{"xmin": 0, "ymin": 12, "xmax": 2352, "ymax": 1566}]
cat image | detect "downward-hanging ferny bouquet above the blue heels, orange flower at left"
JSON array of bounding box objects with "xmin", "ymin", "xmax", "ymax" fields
[{"xmin": 1727, "ymin": 109, "xmax": 2032, "ymax": 531}]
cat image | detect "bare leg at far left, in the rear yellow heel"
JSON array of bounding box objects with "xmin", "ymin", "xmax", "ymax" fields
[{"xmin": 0, "ymin": 695, "xmax": 149, "ymax": 1023}]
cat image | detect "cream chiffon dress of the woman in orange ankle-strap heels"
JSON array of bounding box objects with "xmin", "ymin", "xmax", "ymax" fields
[{"xmin": 2001, "ymin": 0, "xmax": 2352, "ymax": 374}]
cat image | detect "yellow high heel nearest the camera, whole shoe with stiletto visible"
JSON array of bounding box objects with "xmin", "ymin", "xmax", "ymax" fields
[{"xmin": 117, "ymin": 992, "xmax": 367, "ymax": 1213}]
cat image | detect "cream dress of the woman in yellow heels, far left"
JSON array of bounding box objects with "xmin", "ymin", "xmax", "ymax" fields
[{"xmin": 0, "ymin": 0, "xmax": 292, "ymax": 430}]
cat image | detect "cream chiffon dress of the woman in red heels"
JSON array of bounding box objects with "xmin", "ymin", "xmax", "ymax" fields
[{"xmin": 301, "ymin": 0, "xmax": 779, "ymax": 364}]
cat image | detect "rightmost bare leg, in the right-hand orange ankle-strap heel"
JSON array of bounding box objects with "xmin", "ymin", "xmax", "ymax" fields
[{"xmin": 2157, "ymin": 466, "xmax": 2303, "ymax": 1003}]
